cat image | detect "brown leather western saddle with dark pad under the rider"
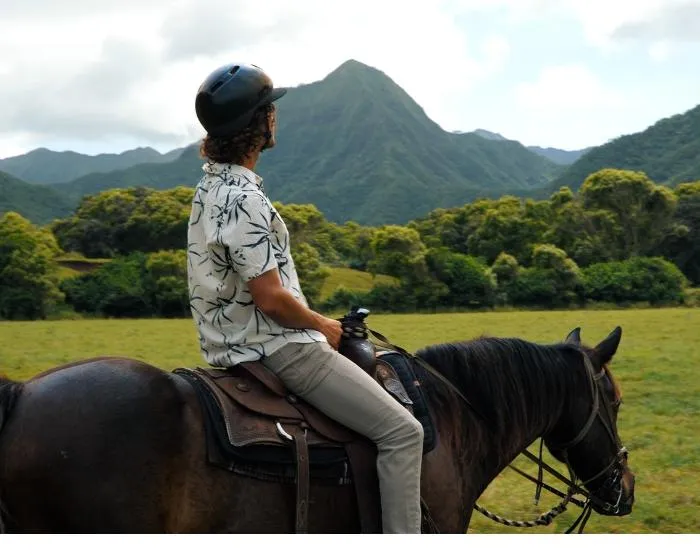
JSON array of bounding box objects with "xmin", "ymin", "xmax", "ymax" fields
[{"xmin": 173, "ymin": 352, "xmax": 435, "ymax": 533}]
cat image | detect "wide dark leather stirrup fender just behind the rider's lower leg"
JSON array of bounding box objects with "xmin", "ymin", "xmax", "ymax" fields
[{"xmin": 345, "ymin": 439, "xmax": 382, "ymax": 533}]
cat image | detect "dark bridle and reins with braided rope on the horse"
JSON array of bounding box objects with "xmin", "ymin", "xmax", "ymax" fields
[{"xmin": 365, "ymin": 328, "xmax": 627, "ymax": 534}]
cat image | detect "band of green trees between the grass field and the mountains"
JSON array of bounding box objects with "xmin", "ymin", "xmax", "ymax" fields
[{"xmin": 0, "ymin": 169, "xmax": 700, "ymax": 319}]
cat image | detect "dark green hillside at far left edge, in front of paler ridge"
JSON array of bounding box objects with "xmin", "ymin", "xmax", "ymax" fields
[{"xmin": 0, "ymin": 172, "xmax": 74, "ymax": 224}]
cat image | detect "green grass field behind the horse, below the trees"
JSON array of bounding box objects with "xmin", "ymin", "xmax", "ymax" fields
[{"xmin": 0, "ymin": 309, "xmax": 700, "ymax": 534}]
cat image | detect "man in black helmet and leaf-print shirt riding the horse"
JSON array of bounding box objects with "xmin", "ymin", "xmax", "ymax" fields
[{"xmin": 188, "ymin": 63, "xmax": 423, "ymax": 533}]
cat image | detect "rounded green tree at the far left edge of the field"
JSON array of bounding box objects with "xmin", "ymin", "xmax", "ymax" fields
[{"xmin": 0, "ymin": 212, "xmax": 62, "ymax": 319}]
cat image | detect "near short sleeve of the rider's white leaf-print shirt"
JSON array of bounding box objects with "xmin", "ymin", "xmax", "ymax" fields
[{"xmin": 217, "ymin": 193, "xmax": 277, "ymax": 282}]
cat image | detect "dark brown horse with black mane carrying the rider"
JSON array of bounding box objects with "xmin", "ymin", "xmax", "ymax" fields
[{"xmin": 0, "ymin": 328, "xmax": 634, "ymax": 533}]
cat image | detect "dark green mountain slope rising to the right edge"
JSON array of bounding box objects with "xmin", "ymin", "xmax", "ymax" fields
[{"xmin": 551, "ymin": 105, "xmax": 700, "ymax": 190}]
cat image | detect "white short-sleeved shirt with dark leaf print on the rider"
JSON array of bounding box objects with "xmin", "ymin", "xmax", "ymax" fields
[{"xmin": 187, "ymin": 162, "xmax": 326, "ymax": 367}]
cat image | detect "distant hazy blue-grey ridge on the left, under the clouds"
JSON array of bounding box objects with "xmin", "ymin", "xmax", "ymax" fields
[{"xmin": 0, "ymin": 147, "xmax": 183, "ymax": 184}]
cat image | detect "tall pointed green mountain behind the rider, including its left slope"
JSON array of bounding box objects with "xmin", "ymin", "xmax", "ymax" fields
[{"xmin": 52, "ymin": 61, "xmax": 561, "ymax": 224}]
